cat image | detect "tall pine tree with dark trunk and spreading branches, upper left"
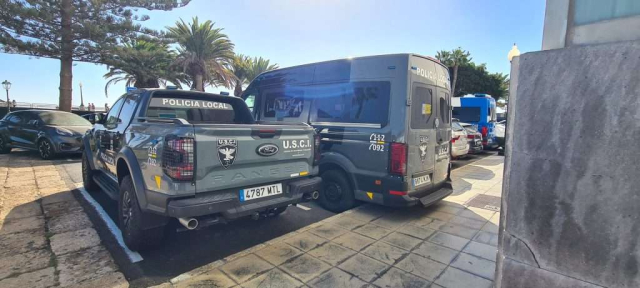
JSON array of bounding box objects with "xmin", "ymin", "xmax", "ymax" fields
[{"xmin": 0, "ymin": 0, "xmax": 190, "ymax": 111}]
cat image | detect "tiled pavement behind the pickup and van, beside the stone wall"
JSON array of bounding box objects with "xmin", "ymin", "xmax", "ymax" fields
[{"xmin": 162, "ymin": 156, "xmax": 503, "ymax": 288}]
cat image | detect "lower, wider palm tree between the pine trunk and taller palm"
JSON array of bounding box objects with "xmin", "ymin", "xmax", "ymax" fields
[{"xmin": 103, "ymin": 40, "xmax": 181, "ymax": 95}]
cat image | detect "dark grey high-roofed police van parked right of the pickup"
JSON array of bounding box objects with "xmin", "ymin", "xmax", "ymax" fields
[{"xmin": 242, "ymin": 54, "xmax": 452, "ymax": 212}]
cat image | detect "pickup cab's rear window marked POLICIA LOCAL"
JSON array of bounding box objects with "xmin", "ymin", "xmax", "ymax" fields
[{"xmin": 146, "ymin": 97, "xmax": 236, "ymax": 124}]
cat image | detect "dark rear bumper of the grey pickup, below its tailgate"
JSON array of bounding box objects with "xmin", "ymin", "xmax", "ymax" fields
[{"xmin": 166, "ymin": 177, "xmax": 322, "ymax": 220}]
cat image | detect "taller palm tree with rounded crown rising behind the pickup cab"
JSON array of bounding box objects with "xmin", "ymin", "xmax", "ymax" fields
[{"xmin": 167, "ymin": 17, "xmax": 234, "ymax": 91}]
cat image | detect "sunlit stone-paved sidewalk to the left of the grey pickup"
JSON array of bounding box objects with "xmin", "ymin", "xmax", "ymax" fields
[{"xmin": 0, "ymin": 151, "xmax": 129, "ymax": 288}]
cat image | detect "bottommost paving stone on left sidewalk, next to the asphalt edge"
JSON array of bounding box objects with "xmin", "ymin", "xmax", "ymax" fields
[{"xmin": 57, "ymin": 246, "xmax": 118, "ymax": 287}]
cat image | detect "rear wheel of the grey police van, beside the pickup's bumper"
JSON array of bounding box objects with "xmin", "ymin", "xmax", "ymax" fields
[{"xmin": 319, "ymin": 170, "xmax": 356, "ymax": 213}]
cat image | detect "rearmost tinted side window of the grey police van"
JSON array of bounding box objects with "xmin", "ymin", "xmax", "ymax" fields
[{"xmin": 305, "ymin": 81, "xmax": 391, "ymax": 126}]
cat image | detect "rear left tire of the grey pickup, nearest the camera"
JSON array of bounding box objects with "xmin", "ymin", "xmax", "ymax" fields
[{"xmin": 118, "ymin": 175, "xmax": 164, "ymax": 251}]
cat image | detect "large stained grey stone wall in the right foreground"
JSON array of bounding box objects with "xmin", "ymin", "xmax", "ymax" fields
[{"xmin": 496, "ymin": 41, "xmax": 640, "ymax": 288}]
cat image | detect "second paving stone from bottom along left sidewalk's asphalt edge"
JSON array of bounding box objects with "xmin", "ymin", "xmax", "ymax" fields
[{"xmin": 49, "ymin": 228, "xmax": 100, "ymax": 256}]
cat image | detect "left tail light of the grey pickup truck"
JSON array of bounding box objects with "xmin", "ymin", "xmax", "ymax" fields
[{"xmin": 162, "ymin": 136, "xmax": 195, "ymax": 181}]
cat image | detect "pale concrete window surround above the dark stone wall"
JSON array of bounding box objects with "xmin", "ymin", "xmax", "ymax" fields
[{"xmin": 542, "ymin": 0, "xmax": 640, "ymax": 50}]
